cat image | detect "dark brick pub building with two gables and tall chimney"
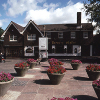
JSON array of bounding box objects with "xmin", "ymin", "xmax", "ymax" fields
[{"xmin": 1, "ymin": 12, "xmax": 93, "ymax": 58}]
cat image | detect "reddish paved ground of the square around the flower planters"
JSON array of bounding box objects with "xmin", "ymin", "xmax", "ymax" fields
[{"xmin": 0, "ymin": 59, "xmax": 100, "ymax": 100}]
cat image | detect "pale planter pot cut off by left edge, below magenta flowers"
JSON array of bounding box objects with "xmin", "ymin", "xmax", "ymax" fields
[{"xmin": 0, "ymin": 78, "xmax": 14, "ymax": 96}]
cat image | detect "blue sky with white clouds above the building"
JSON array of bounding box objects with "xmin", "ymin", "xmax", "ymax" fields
[{"xmin": 0, "ymin": 0, "xmax": 95, "ymax": 34}]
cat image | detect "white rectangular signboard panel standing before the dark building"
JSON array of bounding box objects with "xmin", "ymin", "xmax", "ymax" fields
[{"xmin": 39, "ymin": 37, "xmax": 48, "ymax": 50}]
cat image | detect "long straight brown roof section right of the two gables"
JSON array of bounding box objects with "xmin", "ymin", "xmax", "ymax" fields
[{"xmin": 38, "ymin": 23, "xmax": 93, "ymax": 31}]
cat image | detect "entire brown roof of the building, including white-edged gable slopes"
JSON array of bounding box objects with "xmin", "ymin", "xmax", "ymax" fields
[{"xmin": 1, "ymin": 20, "xmax": 93, "ymax": 37}]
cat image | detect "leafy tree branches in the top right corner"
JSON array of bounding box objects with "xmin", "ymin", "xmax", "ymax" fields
[{"xmin": 82, "ymin": 0, "xmax": 100, "ymax": 33}]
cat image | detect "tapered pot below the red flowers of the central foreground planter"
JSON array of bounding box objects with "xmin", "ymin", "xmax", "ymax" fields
[{"xmin": 47, "ymin": 73, "xmax": 65, "ymax": 85}]
